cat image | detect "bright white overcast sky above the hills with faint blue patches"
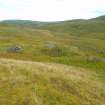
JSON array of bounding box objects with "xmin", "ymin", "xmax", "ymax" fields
[{"xmin": 0, "ymin": 0, "xmax": 105, "ymax": 21}]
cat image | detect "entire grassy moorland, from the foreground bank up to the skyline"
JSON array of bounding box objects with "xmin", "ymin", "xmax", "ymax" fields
[{"xmin": 0, "ymin": 16, "xmax": 105, "ymax": 105}]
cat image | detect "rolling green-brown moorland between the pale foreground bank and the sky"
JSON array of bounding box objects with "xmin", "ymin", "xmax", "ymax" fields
[{"xmin": 0, "ymin": 16, "xmax": 105, "ymax": 71}]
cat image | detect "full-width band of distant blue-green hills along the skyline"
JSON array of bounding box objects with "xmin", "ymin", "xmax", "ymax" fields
[{"xmin": 0, "ymin": 16, "xmax": 105, "ymax": 36}]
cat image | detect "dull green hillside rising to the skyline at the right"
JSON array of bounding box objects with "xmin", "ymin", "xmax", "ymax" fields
[{"xmin": 39, "ymin": 16, "xmax": 105, "ymax": 38}]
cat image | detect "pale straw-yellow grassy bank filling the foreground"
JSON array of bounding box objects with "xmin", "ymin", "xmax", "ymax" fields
[{"xmin": 0, "ymin": 59, "xmax": 105, "ymax": 105}]
